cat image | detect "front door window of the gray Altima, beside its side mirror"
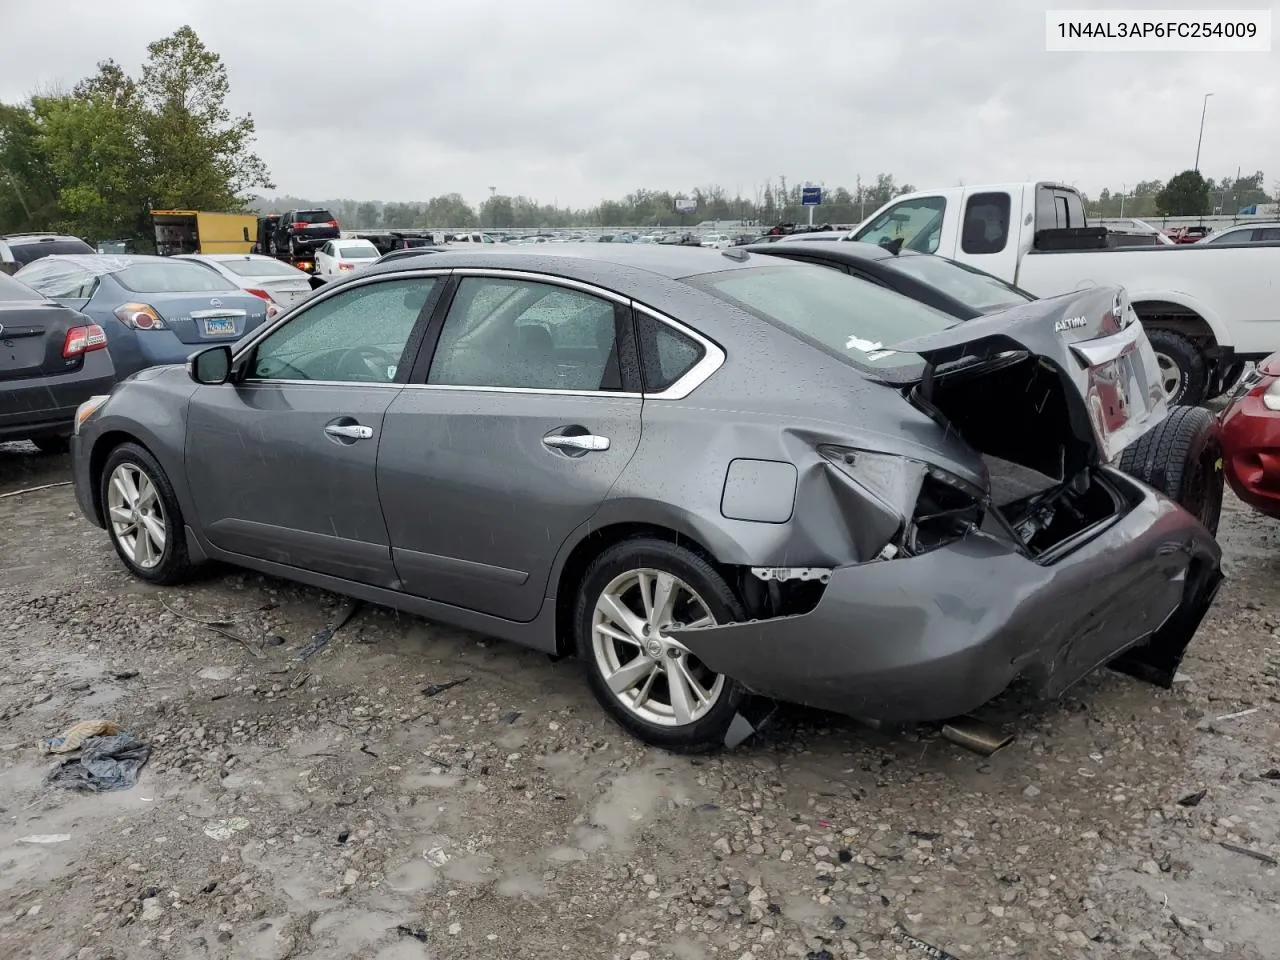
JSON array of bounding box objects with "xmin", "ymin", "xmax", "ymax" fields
[{"xmin": 251, "ymin": 276, "xmax": 439, "ymax": 383}]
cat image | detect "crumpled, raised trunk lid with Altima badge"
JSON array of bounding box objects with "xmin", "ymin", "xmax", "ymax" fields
[{"xmin": 892, "ymin": 287, "xmax": 1169, "ymax": 480}]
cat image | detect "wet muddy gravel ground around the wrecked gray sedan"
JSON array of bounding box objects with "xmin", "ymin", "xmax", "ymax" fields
[{"xmin": 0, "ymin": 445, "xmax": 1280, "ymax": 960}]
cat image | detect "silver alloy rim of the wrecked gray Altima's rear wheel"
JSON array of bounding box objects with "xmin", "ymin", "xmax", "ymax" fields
[{"xmin": 591, "ymin": 567, "xmax": 724, "ymax": 727}]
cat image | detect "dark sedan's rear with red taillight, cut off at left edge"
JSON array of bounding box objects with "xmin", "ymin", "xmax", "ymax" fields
[{"xmin": 0, "ymin": 275, "xmax": 115, "ymax": 453}]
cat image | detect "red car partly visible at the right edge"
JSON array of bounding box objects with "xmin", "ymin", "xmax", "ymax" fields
[{"xmin": 1219, "ymin": 353, "xmax": 1280, "ymax": 518}]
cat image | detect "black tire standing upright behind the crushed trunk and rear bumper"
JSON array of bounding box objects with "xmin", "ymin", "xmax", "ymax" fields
[{"xmin": 1120, "ymin": 407, "xmax": 1224, "ymax": 536}]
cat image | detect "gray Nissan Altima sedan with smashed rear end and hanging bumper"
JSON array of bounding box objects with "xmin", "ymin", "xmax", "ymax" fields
[{"xmin": 73, "ymin": 244, "xmax": 1221, "ymax": 749}]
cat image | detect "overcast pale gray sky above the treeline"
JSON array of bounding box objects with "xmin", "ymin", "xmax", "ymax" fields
[{"xmin": 0, "ymin": 0, "xmax": 1280, "ymax": 206}]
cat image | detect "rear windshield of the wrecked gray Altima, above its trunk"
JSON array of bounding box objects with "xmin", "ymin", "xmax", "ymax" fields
[{"xmin": 685, "ymin": 264, "xmax": 959, "ymax": 370}]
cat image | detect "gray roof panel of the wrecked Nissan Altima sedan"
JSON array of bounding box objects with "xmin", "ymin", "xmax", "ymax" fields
[{"xmin": 361, "ymin": 243, "xmax": 774, "ymax": 283}]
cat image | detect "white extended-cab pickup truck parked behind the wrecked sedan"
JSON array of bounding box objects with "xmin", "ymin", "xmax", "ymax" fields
[{"xmin": 846, "ymin": 182, "xmax": 1280, "ymax": 404}]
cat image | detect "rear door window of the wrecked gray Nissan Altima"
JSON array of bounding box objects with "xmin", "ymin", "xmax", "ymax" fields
[{"xmin": 426, "ymin": 276, "xmax": 622, "ymax": 390}]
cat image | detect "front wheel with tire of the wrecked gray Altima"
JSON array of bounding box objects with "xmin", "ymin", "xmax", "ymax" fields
[{"xmin": 101, "ymin": 443, "xmax": 193, "ymax": 586}]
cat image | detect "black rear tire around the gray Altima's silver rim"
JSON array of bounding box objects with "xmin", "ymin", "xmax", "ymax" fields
[{"xmin": 573, "ymin": 538, "xmax": 748, "ymax": 753}]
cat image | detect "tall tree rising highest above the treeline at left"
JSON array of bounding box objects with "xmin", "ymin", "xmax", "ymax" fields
[{"xmin": 137, "ymin": 26, "xmax": 275, "ymax": 210}]
